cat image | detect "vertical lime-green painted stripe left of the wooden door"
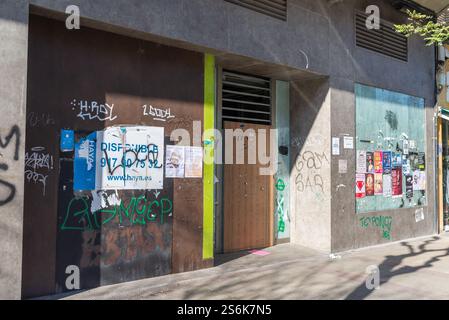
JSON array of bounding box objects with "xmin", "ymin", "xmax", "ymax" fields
[{"xmin": 203, "ymin": 54, "xmax": 215, "ymax": 259}]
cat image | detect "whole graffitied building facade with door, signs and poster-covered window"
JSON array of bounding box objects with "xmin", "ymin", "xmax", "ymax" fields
[{"xmin": 0, "ymin": 0, "xmax": 441, "ymax": 298}]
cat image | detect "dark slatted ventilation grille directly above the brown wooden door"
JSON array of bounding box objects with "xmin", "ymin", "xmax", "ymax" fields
[{"xmin": 222, "ymin": 71, "xmax": 271, "ymax": 124}]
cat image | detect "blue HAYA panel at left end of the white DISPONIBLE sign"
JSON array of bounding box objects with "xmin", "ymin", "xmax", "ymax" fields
[{"xmin": 73, "ymin": 132, "xmax": 97, "ymax": 191}]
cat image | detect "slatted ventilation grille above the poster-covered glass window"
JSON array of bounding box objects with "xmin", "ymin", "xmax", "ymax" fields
[{"xmin": 355, "ymin": 12, "xmax": 408, "ymax": 61}]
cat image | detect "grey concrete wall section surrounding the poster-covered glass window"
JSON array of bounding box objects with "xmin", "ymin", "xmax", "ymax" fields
[{"xmin": 329, "ymin": 1, "xmax": 436, "ymax": 251}]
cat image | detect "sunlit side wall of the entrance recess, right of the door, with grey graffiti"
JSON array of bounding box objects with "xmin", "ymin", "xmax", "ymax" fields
[{"xmin": 290, "ymin": 78, "xmax": 332, "ymax": 251}]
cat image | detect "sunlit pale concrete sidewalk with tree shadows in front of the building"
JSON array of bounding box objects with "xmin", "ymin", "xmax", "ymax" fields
[{"xmin": 43, "ymin": 235, "xmax": 449, "ymax": 300}]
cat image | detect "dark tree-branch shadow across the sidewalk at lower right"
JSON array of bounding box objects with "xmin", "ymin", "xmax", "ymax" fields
[{"xmin": 346, "ymin": 237, "xmax": 449, "ymax": 300}]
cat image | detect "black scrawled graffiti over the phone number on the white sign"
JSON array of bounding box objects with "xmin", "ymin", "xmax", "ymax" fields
[{"xmin": 103, "ymin": 143, "xmax": 162, "ymax": 175}]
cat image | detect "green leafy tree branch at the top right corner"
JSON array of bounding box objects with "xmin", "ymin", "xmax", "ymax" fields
[{"xmin": 394, "ymin": 10, "xmax": 449, "ymax": 46}]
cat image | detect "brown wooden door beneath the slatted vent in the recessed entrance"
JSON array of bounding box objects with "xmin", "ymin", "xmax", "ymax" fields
[{"xmin": 224, "ymin": 121, "xmax": 273, "ymax": 252}]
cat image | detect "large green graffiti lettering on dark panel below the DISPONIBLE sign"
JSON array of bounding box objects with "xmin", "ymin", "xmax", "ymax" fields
[{"xmin": 61, "ymin": 195, "xmax": 173, "ymax": 231}]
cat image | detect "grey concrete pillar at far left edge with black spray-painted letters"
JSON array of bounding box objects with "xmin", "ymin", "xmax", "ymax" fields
[{"xmin": 0, "ymin": 0, "xmax": 28, "ymax": 299}]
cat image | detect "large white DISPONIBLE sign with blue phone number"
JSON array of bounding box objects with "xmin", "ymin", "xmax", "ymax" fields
[{"xmin": 95, "ymin": 126, "xmax": 164, "ymax": 190}]
